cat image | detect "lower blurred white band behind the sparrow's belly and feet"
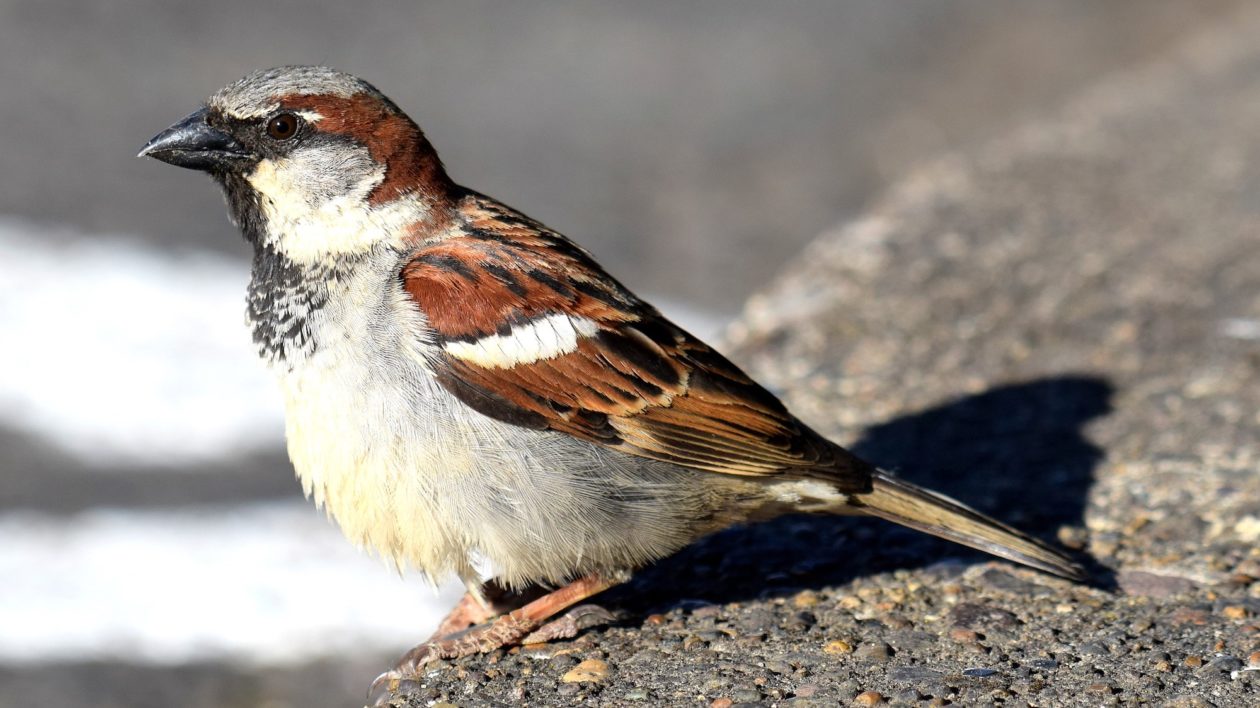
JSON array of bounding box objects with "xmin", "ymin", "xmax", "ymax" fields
[{"xmin": 0, "ymin": 501, "xmax": 462, "ymax": 664}]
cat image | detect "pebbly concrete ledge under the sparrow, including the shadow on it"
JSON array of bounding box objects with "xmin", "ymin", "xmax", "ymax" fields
[{"xmin": 380, "ymin": 14, "xmax": 1260, "ymax": 707}]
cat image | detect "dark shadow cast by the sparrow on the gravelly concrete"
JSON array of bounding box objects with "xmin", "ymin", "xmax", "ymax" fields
[{"xmin": 600, "ymin": 375, "xmax": 1113, "ymax": 614}]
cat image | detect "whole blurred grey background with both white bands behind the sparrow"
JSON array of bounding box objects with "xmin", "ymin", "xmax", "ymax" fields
[{"xmin": 0, "ymin": 0, "xmax": 1242, "ymax": 707}]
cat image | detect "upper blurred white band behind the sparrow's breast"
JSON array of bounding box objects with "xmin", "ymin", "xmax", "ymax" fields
[{"xmin": 0, "ymin": 218, "xmax": 284, "ymax": 466}]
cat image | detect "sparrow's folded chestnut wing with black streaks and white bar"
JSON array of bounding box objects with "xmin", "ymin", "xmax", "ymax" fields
[{"xmin": 402, "ymin": 192, "xmax": 872, "ymax": 491}]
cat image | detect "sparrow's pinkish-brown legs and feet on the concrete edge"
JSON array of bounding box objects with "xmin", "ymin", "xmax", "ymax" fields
[{"xmin": 370, "ymin": 574, "xmax": 629, "ymax": 693}]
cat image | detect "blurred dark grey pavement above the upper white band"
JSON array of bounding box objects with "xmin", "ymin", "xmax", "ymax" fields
[{"xmin": 0, "ymin": 0, "xmax": 1239, "ymax": 312}]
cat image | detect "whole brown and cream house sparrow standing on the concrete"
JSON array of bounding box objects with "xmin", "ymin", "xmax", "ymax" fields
[{"xmin": 140, "ymin": 67, "xmax": 1084, "ymax": 679}]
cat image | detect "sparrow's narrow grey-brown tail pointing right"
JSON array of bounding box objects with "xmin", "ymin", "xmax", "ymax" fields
[{"xmin": 849, "ymin": 471, "xmax": 1086, "ymax": 581}]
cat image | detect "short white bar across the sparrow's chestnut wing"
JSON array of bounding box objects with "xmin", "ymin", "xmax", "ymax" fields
[{"xmin": 442, "ymin": 312, "xmax": 599, "ymax": 369}]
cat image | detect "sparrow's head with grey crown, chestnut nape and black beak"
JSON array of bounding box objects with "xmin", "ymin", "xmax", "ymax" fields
[{"xmin": 140, "ymin": 67, "xmax": 452, "ymax": 263}]
